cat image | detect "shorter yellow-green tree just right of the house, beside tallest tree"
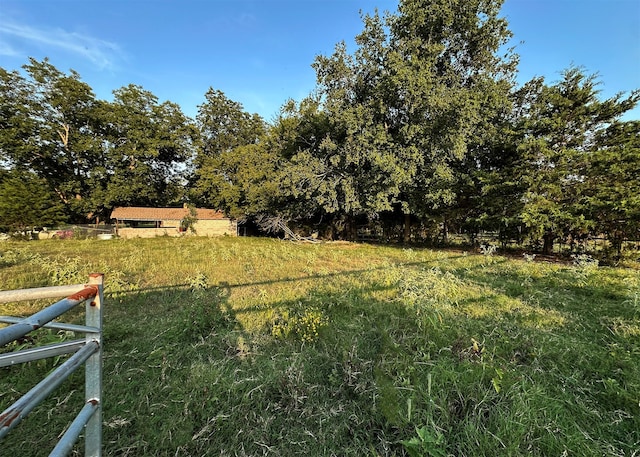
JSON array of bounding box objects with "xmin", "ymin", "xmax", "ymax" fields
[{"xmin": 194, "ymin": 95, "xmax": 336, "ymax": 232}]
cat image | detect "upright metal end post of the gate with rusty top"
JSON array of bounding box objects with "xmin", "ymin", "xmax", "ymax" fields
[{"xmin": 85, "ymin": 273, "xmax": 104, "ymax": 457}]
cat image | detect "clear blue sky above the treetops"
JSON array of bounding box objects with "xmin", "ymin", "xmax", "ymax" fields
[{"xmin": 0, "ymin": 0, "xmax": 640, "ymax": 120}]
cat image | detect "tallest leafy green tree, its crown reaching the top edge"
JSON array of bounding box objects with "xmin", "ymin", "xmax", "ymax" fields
[{"xmin": 314, "ymin": 0, "xmax": 516, "ymax": 240}]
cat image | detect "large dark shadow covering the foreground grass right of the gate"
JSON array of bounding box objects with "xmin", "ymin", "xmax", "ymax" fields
[{"xmin": 97, "ymin": 270, "xmax": 638, "ymax": 456}]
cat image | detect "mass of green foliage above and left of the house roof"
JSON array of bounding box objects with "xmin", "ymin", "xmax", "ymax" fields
[{"xmin": 0, "ymin": 59, "xmax": 195, "ymax": 221}]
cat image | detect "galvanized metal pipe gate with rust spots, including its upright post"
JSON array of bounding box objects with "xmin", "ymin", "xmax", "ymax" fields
[{"xmin": 0, "ymin": 273, "xmax": 104, "ymax": 457}]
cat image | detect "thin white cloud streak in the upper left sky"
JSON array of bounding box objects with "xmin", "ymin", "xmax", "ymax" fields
[{"xmin": 0, "ymin": 21, "xmax": 121, "ymax": 68}]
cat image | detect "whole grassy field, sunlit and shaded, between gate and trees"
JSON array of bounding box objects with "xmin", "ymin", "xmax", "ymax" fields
[{"xmin": 0, "ymin": 238, "xmax": 640, "ymax": 457}]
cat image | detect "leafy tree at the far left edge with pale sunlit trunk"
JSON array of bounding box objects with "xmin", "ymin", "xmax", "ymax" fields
[{"xmin": 0, "ymin": 58, "xmax": 102, "ymax": 219}]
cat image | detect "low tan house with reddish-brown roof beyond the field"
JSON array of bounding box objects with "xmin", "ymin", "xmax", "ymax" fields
[{"xmin": 111, "ymin": 205, "xmax": 238, "ymax": 238}]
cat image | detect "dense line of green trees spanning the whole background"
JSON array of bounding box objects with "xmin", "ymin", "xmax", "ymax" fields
[{"xmin": 0, "ymin": 0, "xmax": 640, "ymax": 252}]
